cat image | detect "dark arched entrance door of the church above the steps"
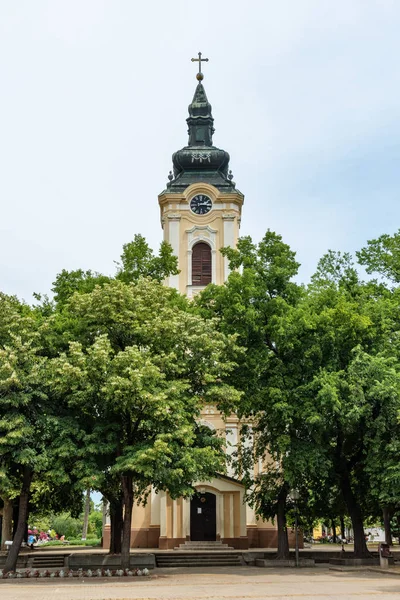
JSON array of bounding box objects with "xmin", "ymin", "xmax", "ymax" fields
[{"xmin": 190, "ymin": 492, "xmax": 217, "ymax": 542}]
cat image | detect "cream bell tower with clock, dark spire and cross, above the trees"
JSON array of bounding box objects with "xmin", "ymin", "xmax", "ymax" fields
[{"xmin": 158, "ymin": 52, "xmax": 244, "ymax": 298}]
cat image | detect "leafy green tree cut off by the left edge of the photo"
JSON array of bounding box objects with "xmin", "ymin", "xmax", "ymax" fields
[{"xmin": 0, "ymin": 296, "xmax": 82, "ymax": 571}]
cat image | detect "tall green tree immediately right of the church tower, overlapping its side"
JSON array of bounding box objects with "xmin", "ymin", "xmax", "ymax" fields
[{"xmin": 197, "ymin": 231, "xmax": 304, "ymax": 558}]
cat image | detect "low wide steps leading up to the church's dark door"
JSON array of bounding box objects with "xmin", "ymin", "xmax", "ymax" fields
[{"xmin": 155, "ymin": 542, "xmax": 243, "ymax": 568}]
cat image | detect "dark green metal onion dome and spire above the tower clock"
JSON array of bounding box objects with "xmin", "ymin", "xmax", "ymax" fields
[{"xmin": 167, "ymin": 77, "xmax": 235, "ymax": 192}]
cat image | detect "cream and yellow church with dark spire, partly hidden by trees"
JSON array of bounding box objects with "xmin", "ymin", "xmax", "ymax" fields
[{"xmin": 103, "ymin": 53, "xmax": 277, "ymax": 549}]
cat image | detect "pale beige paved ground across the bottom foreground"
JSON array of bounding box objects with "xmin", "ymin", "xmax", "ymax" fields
[{"xmin": 0, "ymin": 565, "xmax": 400, "ymax": 600}]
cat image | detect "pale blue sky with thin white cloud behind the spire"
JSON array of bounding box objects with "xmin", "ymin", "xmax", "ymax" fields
[{"xmin": 0, "ymin": 0, "xmax": 400, "ymax": 302}]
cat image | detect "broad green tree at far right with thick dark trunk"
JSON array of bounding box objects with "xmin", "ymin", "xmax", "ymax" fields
[{"xmin": 294, "ymin": 253, "xmax": 399, "ymax": 557}]
